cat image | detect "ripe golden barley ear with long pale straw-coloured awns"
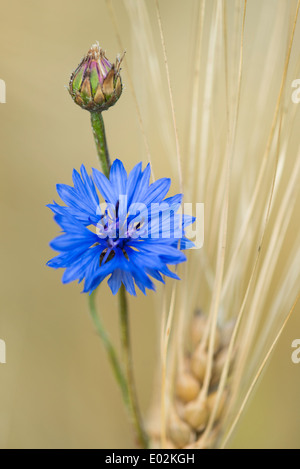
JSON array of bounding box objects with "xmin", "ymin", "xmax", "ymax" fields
[{"xmin": 107, "ymin": 0, "xmax": 300, "ymax": 448}]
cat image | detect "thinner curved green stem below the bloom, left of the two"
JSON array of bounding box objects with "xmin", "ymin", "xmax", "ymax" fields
[{"xmin": 89, "ymin": 291, "xmax": 130, "ymax": 408}]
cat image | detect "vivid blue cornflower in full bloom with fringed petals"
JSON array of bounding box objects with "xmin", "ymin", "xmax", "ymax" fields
[{"xmin": 47, "ymin": 160, "xmax": 194, "ymax": 295}]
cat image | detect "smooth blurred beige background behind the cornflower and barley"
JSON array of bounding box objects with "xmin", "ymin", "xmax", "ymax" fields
[{"xmin": 0, "ymin": 0, "xmax": 300, "ymax": 448}]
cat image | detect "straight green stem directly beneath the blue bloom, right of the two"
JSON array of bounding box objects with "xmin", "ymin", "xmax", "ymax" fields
[{"xmin": 119, "ymin": 285, "xmax": 148, "ymax": 448}]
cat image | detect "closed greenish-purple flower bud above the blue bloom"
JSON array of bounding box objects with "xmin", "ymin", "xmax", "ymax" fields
[{"xmin": 69, "ymin": 43, "xmax": 123, "ymax": 112}]
